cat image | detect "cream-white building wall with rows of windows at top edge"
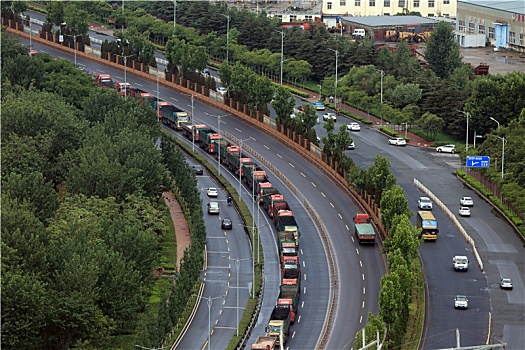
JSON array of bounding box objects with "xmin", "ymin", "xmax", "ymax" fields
[{"xmin": 322, "ymin": 0, "xmax": 457, "ymax": 18}]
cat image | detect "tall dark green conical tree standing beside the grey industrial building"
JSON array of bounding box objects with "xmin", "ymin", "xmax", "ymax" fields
[{"xmin": 425, "ymin": 22, "xmax": 462, "ymax": 78}]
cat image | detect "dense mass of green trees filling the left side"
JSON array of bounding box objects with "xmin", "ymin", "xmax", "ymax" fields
[{"xmin": 1, "ymin": 31, "xmax": 194, "ymax": 349}]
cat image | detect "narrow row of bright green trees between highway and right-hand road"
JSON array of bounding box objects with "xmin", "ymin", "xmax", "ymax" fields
[{"xmin": 349, "ymin": 156, "xmax": 421, "ymax": 348}]
